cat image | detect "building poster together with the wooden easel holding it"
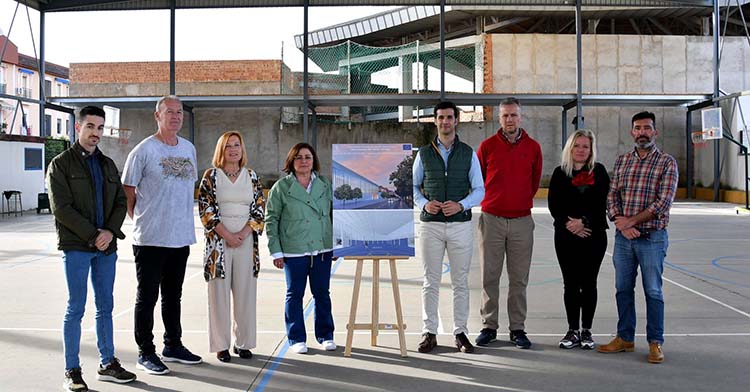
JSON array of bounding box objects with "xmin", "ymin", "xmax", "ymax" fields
[{"xmin": 332, "ymin": 144, "xmax": 414, "ymax": 357}]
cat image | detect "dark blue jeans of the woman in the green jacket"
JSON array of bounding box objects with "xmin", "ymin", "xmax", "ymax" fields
[{"xmin": 284, "ymin": 252, "xmax": 334, "ymax": 345}]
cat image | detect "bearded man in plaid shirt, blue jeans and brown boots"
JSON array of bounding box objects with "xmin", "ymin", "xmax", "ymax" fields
[{"xmin": 598, "ymin": 112, "xmax": 677, "ymax": 363}]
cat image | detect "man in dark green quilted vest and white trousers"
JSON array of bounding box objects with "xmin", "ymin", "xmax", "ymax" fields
[{"xmin": 412, "ymin": 102, "xmax": 484, "ymax": 353}]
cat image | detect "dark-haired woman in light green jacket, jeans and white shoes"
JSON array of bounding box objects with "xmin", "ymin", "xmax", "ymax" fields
[{"xmin": 266, "ymin": 143, "xmax": 336, "ymax": 354}]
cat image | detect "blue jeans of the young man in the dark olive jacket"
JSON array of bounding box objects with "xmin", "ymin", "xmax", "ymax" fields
[{"xmin": 63, "ymin": 250, "xmax": 117, "ymax": 370}]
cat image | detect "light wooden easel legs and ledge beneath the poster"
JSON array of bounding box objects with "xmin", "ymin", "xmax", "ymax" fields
[{"xmin": 344, "ymin": 256, "xmax": 409, "ymax": 357}]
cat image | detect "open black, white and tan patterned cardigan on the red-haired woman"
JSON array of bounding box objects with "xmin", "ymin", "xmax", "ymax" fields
[{"xmin": 198, "ymin": 168, "xmax": 266, "ymax": 282}]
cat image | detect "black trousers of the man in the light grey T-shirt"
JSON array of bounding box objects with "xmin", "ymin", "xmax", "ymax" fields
[{"xmin": 133, "ymin": 245, "xmax": 190, "ymax": 355}]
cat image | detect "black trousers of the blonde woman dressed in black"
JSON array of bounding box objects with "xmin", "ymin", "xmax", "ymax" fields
[{"xmin": 555, "ymin": 228, "xmax": 607, "ymax": 330}]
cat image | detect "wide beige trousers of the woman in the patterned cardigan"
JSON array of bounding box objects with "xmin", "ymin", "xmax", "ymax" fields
[{"xmin": 208, "ymin": 230, "xmax": 258, "ymax": 352}]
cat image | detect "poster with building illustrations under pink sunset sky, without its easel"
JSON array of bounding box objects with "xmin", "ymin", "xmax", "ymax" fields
[{"xmin": 333, "ymin": 144, "xmax": 414, "ymax": 256}]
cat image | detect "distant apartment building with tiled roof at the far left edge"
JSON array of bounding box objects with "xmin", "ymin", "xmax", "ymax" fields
[{"xmin": 0, "ymin": 35, "xmax": 72, "ymax": 137}]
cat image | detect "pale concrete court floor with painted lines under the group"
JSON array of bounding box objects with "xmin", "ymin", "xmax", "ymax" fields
[{"xmin": 0, "ymin": 200, "xmax": 750, "ymax": 392}]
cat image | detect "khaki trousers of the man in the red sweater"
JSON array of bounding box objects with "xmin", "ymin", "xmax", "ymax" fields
[{"xmin": 479, "ymin": 212, "xmax": 534, "ymax": 331}]
